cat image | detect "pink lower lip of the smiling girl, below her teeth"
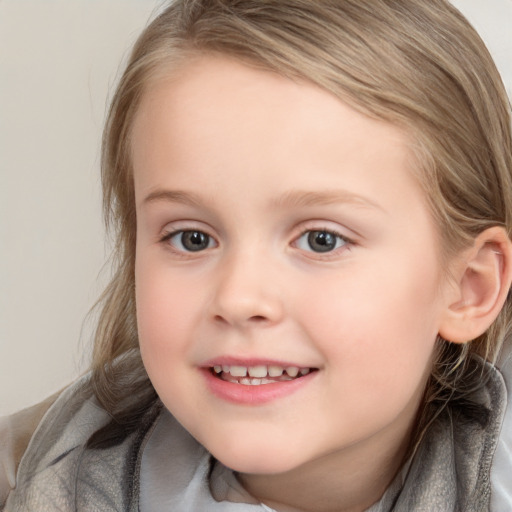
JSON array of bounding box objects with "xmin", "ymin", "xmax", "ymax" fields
[{"xmin": 201, "ymin": 368, "xmax": 318, "ymax": 405}]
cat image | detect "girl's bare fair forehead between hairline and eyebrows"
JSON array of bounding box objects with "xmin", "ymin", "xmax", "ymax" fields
[{"xmin": 132, "ymin": 56, "xmax": 418, "ymax": 194}]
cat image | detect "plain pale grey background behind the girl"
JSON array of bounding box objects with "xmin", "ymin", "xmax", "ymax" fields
[{"xmin": 0, "ymin": 0, "xmax": 512, "ymax": 415}]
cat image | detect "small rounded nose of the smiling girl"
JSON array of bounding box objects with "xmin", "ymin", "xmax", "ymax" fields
[{"xmin": 212, "ymin": 248, "xmax": 284, "ymax": 328}]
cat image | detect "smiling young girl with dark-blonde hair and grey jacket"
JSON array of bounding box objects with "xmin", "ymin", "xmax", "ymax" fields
[{"xmin": 4, "ymin": 0, "xmax": 512, "ymax": 512}]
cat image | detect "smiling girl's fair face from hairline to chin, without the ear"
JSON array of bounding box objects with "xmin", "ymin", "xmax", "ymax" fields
[{"xmin": 132, "ymin": 57, "xmax": 456, "ymax": 474}]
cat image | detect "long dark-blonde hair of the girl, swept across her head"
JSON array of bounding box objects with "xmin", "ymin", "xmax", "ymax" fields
[{"xmin": 88, "ymin": 0, "xmax": 512, "ymax": 448}]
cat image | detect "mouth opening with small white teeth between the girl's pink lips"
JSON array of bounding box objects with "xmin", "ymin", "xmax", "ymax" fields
[{"xmin": 210, "ymin": 365, "xmax": 318, "ymax": 386}]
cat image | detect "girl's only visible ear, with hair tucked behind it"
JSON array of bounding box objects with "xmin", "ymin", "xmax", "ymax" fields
[{"xmin": 439, "ymin": 226, "xmax": 512, "ymax": 343}]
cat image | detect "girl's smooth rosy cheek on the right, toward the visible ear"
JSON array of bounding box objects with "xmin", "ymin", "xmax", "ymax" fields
[{"xmin": 301, "ymin": 261, "xmax": 439, "ymax": 380}]
